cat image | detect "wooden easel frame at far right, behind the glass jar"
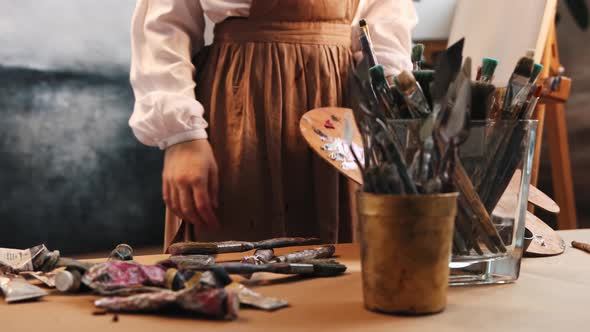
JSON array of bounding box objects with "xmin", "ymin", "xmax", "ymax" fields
[{"xmin": 531, "ymin": 23, "xmax": 577, "ymax": 230}]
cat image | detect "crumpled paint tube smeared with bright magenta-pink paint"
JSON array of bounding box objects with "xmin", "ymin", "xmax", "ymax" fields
[{"xmin": 82, "ymin": 261, "xmax": 166, "ymax": 293}]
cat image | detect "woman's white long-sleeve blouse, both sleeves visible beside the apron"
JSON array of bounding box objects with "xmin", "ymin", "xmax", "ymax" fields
[{"xmin": 129, "ymin": 0, "xmax": 417, "ymax": 149}]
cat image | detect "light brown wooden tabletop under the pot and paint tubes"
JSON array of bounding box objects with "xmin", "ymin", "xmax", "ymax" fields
[{"xmin": 0, "ymin": 230, "xmax": 590, "ymax": 332}]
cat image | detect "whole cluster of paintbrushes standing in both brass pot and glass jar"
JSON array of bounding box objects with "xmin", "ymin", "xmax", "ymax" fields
[{"xmin": 352, "ymin": 20, "xmax": 542, "ymax": 254}]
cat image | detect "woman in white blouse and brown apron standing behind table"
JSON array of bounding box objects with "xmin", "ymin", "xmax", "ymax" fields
[{"xmin": 130, "ymin": 0, "xmax": 415, "ymax": 248}]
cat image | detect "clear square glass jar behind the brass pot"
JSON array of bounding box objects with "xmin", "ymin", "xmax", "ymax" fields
[{"xmin": 390, "ymin": 120, "xmax": 537, "ymax": 285}]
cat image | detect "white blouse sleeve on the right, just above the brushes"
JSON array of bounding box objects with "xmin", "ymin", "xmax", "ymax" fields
[{"xmin": 353, "ymin": 0, "xmax": 418, "ymax": 76}]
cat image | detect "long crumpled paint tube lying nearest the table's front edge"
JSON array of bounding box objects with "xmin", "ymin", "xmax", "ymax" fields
[{"xmin": 94, "ymin": 287, "xmax": 240, "ymax": 320}]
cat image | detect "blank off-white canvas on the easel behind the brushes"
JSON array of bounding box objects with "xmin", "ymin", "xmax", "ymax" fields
[{"xmin": 449, "ymin": 0, "xmax": 557, "ymax": 86}]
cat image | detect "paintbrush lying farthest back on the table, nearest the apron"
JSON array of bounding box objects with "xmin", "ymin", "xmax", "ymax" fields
[{"xmin": 168, "ymin": 237, "xmax": 319, "ymax": 255}]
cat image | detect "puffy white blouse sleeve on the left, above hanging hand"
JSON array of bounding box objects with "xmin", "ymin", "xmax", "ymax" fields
[{"xmin": 129, "ymin": 0, "xmax": 207, "ymax": 149}]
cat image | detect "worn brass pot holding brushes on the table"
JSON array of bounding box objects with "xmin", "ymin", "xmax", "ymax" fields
[{"xmin": 357, "ymin": 192, "xmax": 458, "ymax": 315}]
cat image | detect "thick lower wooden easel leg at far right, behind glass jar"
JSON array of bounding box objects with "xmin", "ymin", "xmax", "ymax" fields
[{"xmin": 545, "ymin": 103, "xmax": 577, "ymax": 230}]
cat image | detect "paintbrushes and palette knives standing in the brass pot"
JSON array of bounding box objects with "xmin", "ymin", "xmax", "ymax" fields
[{"xmin": 345, "ymin": 20, "xmax": 471, "ymax": 194}]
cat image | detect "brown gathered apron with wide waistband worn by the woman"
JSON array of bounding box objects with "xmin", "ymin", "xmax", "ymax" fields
[{"xmin": 165, "ymin": 0, "xmax": 358, "ymax": 248}]
